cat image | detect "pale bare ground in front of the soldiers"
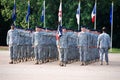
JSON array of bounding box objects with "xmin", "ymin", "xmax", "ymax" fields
[{"xmin": 0, "ymin": 51, "xmax": 120, "ymax": 80}]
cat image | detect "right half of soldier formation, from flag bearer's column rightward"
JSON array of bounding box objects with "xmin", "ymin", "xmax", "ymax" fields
[{"xmin": 57, "ymin": 26, "xmax": 100, "ymax": 66}]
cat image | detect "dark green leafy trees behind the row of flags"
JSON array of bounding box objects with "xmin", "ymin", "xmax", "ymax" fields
[{"xmin": 0, "ymin": 0, "xmax": 120, "ymax": 47}]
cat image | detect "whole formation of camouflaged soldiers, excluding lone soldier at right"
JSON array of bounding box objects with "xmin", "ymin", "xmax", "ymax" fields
[{"xmin": 7, "ymin": 25, "xmax": 99, "ymax": 66}]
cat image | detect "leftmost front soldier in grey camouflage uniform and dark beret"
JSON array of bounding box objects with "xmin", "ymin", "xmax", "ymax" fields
[{"xmin": 7, "ymin": 25, "xmax": 18, "ymax": 64}]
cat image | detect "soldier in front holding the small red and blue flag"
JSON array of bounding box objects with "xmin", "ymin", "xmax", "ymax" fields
[{"xmin": 57, "ymin": 28, "xmax": 68, "ymax": 66}]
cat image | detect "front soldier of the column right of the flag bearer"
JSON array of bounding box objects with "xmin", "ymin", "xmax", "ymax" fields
[{"xmin": 78, "ymin": 26, "xmax": 88, "ymax": 65}]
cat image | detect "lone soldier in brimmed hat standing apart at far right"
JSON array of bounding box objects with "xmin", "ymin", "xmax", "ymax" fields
[{"xmin": 97, "ymin": 27, "xmax": 111, "ymax": 65}]
